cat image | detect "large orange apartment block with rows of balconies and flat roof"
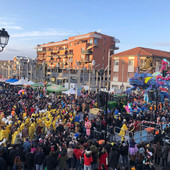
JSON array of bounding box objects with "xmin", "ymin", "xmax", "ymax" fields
[{"xmin": 36, "ymin": 32, "xmax": 119, "ymax": 82}]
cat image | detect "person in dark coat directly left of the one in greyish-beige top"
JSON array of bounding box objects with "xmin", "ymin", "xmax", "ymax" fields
[{"xmin": 58, "ymin": 151, "xmax": 68, "ymax": 170}]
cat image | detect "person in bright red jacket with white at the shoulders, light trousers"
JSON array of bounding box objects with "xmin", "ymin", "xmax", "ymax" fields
[{"xmin": 84, "ymin": 149, "xmax": 93, "ymax": 170}]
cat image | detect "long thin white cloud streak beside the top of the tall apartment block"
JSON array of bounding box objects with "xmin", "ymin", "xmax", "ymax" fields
[{"xmin": 11, "ymin": 29, "xmax": 73, "ymax": 38}]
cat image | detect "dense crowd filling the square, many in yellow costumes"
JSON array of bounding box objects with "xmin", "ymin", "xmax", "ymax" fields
[{"xmin": 0, "ymin": 85, "xmax": 170, "ymax": 170}]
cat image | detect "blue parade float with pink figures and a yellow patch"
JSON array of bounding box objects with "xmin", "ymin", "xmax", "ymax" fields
[{"xmin": 126, "ymin": 59, "xmax": 170, "ymax": 102}]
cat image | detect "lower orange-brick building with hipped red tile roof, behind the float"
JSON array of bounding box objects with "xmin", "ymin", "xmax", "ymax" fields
[{"xmin": 110, "ymin": 47, "xmax": 170, "ymax": 90}]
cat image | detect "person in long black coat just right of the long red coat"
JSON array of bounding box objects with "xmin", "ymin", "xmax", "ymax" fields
[{"xmin": 109, "ymin": 146, "xmax": 119, "ymax": 169}]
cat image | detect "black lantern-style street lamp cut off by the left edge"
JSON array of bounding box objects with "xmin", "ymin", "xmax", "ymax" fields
[{"xmin": 0, "ymin": 28, "xmax": 10, "ymax": 52}]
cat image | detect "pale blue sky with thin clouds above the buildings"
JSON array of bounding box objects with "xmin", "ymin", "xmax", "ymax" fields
[{"xmin": 0, "ymin": 0, "xmax": 170, "ymax": 60}]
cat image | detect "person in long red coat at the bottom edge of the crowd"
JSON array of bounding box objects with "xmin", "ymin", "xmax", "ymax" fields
[{"xmin": 99, "ymin": 148, "xmax": 108, "ymax": 170}]
